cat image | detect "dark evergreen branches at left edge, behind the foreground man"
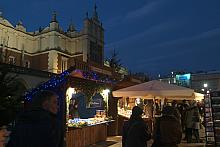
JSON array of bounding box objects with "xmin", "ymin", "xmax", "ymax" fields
[{"xmin": 0, "ymin": 66, "xmax": 25, "ymax": 126}]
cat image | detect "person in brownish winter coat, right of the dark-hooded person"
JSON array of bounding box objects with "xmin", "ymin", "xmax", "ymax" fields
[{"xmin": 152, "ymin": 106, "xmax": 182, "ymax": 147}]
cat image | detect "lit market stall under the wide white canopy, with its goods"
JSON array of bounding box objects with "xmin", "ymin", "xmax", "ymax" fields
[{"xmin": 113, "ymin": 80, "xmax": 201, "ymax": 134}]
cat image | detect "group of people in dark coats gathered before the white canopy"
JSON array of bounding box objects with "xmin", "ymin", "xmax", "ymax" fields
[{"xmin": 122, "ymin": 100, "xmax": 203, "ymax": 147}]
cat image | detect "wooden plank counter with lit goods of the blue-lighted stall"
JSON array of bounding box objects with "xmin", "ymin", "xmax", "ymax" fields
[{"xmin": 66, "ymin": 119, "xmax": 113, "ymax": 147}]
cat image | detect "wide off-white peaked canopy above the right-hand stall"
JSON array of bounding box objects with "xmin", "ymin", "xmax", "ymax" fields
[{"xmin": 113, "ymin": 80, "xmax": 201, "ymax": 100}]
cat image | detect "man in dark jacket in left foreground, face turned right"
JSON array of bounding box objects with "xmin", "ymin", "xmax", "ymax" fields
[{"xmin": 7, "ymin": 90, "xmax": 61, "ymax": 147}]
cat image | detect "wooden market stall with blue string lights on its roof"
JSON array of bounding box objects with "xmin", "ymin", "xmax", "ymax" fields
[{"xmin": 25, "ymin": 68, "xmax": 113, "ymax": 147}]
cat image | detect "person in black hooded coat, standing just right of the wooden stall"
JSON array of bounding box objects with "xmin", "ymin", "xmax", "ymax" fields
[{"xmin": 122, "ymin": 106, "xmax": 151, "ymax": 147}]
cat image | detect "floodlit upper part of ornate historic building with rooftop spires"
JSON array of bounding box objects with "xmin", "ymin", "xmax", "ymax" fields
[{"xmin": 0, "ymin": 6, "xmax": 105, "ymax": 75}]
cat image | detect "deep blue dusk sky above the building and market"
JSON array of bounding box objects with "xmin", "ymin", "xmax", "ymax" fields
[{"xmin": 0, "ymin": 0, "xmax": 220, "ymax": 75}]
